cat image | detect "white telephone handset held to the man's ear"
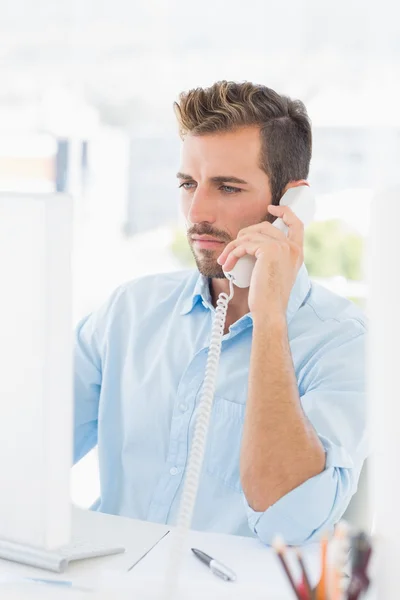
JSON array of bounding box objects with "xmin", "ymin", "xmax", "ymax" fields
[{"xmin": 224, "ymin": 185, "xmax": 315, "ymax": 288}]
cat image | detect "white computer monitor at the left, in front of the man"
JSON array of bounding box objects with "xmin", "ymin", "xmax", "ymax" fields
[{"xmin": 0, "ymin": 193, "xmax": 73, "ymax": 549}]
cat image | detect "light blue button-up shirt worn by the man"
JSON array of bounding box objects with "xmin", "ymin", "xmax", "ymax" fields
[{"xmin": 75, "ymin": 265, "xmax": 367, "ymax": 544}]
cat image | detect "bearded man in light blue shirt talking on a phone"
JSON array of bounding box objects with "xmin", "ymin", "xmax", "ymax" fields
[{"xmin": 75, "ymin": 81, "xmax": 366, "ymax": 544}]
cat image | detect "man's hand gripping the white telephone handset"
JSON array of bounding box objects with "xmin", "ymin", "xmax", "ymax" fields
[{"xmin": 218, "ymin": 205, "xmax": 304, "ymax": 316}]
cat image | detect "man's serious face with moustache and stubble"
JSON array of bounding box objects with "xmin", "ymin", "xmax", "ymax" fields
[{"xmin": 178, "ymin": 127, "xmax": 271, "ymax": 278}]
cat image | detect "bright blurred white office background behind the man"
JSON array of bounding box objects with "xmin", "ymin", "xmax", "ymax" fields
[{"xmin": 0, "ymin": 0, "xmax": 400, "ymax": 506}]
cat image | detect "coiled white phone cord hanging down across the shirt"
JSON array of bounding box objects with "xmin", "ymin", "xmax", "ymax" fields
[{"xmin": 165, "ymin": 279, "xmax": 234, "ymax": 600}]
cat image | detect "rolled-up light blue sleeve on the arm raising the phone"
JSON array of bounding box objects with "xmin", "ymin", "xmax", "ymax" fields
[{"xmin": 244, "ymin": 327, "xmax": 367, "ymax": 545}]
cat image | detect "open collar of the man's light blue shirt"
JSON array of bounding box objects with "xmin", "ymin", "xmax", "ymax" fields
[{"xmin": 180, "ymin": 263, "xmax": 311, "ymax": 323}]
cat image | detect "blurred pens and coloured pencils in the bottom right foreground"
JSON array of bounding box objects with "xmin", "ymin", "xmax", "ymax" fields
[{"xmin": 273, "ymin": 522, "xmax": 372, "ymax": 600}]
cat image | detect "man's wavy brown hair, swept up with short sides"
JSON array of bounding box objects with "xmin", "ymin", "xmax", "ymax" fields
[{"xmin": 174, "ymin": 81, "xmax": 312, "ymax": 204}]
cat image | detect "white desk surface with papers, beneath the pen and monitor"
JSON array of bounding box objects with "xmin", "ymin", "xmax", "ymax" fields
[{"xmin": 0, "ymin": 511, "xmax": 319, "ymax": 600}]
